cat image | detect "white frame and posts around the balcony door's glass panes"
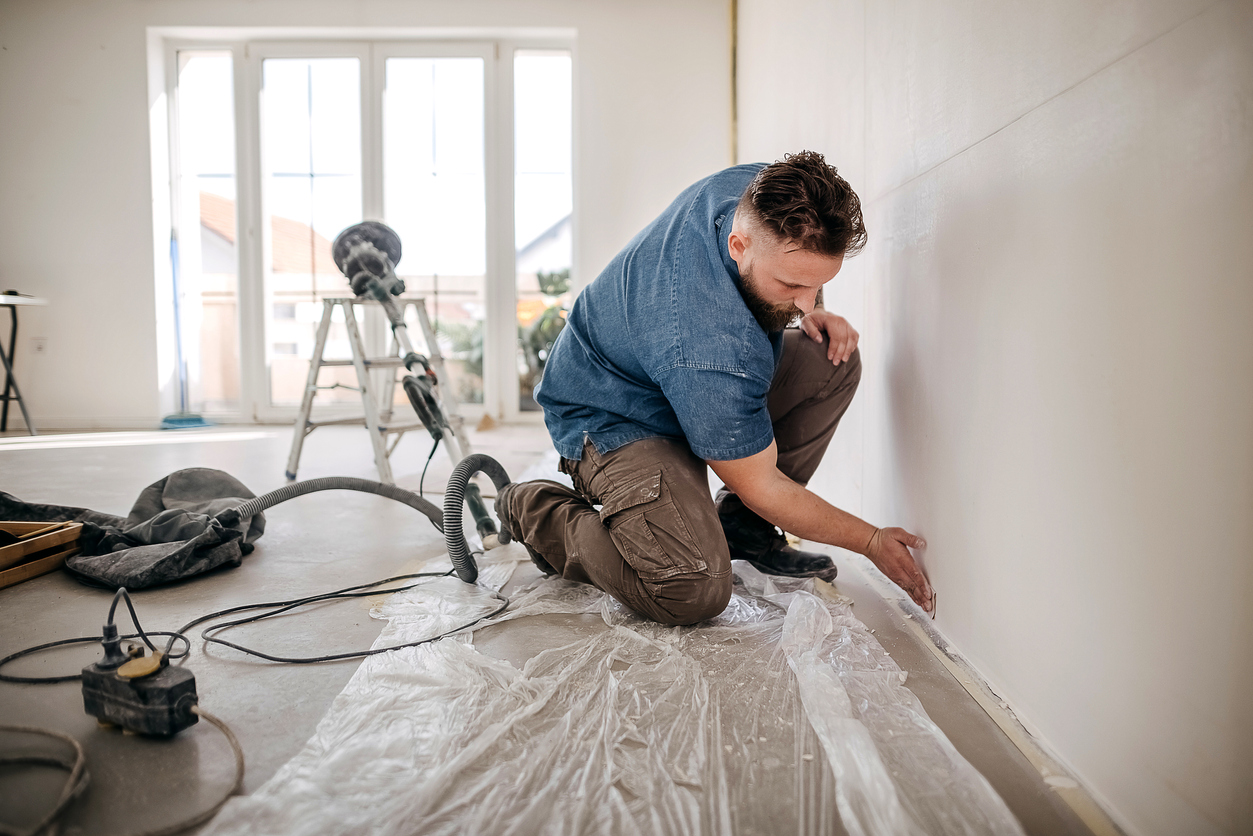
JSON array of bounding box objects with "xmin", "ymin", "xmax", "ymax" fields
[{"xmin": 149, "ymin": 28, "xmax": 579, "ymax": 424}]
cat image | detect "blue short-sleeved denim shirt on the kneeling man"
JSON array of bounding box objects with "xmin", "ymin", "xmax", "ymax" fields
[{"xmin": 535, "ymin": 164, "xmax": 783, "ymax": 461}]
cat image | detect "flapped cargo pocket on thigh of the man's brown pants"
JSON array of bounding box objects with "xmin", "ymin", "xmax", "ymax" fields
[{"xmin": 600, "ymin": 469, "xmax": 708, "ymax": 582}]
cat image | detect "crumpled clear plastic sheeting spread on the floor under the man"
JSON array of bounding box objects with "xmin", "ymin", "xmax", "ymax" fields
[{"xmin": 205, "ymin": 546, "xmax": 1022, "ymax": 836}]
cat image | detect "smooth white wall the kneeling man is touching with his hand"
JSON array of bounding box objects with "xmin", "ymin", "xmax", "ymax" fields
[{"xmin": 737, "ymin": 0, "xmax": 1253, "ymax": 835}]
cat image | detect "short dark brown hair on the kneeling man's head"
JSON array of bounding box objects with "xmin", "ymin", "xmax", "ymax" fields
[{"xmin": 738, "ymin": 150, "xmax": 866, "ymax": 256}]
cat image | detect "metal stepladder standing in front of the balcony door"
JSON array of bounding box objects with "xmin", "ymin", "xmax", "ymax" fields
[{"xmin": 287, "ymin": 297, "xmax": 471, "ymax": 485}]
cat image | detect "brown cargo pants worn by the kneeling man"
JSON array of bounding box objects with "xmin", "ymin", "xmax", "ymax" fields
[{"xmin": 509, "ymin": 330, "xmax": 861, "ymax": 624}]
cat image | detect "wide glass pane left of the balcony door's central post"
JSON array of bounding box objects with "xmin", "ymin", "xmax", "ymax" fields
[{"xmin": 261, "ymin": 58, "xmax": 362, "ymax": 405}]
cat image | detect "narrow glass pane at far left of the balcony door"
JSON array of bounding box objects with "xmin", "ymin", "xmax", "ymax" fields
[{"xmin": 172, "ymin": 51, "xmax": 239, "ymax": 412}]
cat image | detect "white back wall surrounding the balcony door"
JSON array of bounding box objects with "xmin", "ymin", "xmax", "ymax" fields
[{"xmin": 0, "ymin": 0, "xmax": 730, "ymax": 427}]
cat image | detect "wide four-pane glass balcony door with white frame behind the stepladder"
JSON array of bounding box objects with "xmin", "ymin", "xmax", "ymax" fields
[{"xmin": 172, "ymin": 40, "xmax": 573, "ymax": 421}]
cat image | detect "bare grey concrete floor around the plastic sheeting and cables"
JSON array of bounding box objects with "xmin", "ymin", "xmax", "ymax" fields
[{"xmin": 0, "ymin": 426, "xmax": 1090, "ymax": 835}]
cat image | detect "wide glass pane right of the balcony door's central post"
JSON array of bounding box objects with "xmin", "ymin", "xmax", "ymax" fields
[{"xmin": 382, "ymin": 58, "xmax": 487, "ymax": 404}]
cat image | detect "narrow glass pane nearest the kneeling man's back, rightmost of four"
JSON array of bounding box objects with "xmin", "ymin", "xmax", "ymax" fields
[{"xmin": 514, "ymin": 50, "xmax": 574, "ymax": 411}]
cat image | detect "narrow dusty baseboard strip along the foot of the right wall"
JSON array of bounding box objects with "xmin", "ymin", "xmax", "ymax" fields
[{"xmin": 846, "ymin": 553, "xmax": 1131, "ymax": 836}]
